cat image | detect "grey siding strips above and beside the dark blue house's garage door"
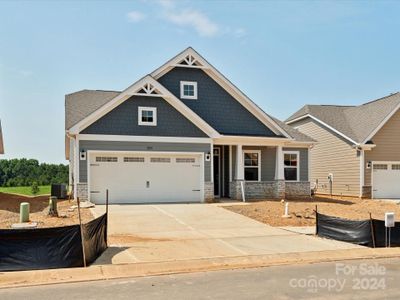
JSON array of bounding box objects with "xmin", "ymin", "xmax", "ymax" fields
[{"xmin": 79, "ymin": 141, "xmax": 211, "ymax": 183}]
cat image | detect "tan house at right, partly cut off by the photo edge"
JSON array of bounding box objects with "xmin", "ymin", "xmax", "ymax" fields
[{"xmin": 286, "ymin": 93, "xmax": 400, "ymax": 198}]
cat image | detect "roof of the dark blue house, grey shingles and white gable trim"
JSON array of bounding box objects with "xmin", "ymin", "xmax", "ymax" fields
[{"xmin": 65, "ymin": 47, "xmax": 312, "ymax": 141}]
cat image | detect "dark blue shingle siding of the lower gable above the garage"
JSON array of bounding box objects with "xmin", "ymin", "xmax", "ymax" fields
[{"xmin": 82, "ymin": 96, "xmax": 207, "ymax": 137}]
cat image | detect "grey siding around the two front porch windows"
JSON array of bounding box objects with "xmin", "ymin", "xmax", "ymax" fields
[{"xmin": 232, "ymin": 146, "xmax": 308, "ymax": 181}]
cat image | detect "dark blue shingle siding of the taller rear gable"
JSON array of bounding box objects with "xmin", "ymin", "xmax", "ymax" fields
[{"xmin": 158, "ymin": 67, "xmax": 276, "ymax": 137}]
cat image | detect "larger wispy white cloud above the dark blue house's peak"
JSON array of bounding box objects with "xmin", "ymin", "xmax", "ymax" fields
[{"xmin": 165, "ymin": 9, "xmax": 220, "ymax": 37}]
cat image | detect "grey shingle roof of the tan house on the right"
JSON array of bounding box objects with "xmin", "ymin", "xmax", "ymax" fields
[{"xmin": 286, "ymin": 93, "xmax": 400, "ymax": 144}]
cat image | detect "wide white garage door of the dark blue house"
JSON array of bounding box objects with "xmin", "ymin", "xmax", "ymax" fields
[{"xmin": 88, "ymin": 152, "xmax": 203, "ymax": 204}]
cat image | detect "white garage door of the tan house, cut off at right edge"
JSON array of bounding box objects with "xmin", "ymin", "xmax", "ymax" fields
[{"xmin": 372, "ymin": 162, "xmax": 400, "ymax": 199}]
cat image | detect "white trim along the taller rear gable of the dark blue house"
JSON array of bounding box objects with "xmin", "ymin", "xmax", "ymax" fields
[{"xmin": 151, "ymin": 47, "xmax": 293, "ymax": 139}]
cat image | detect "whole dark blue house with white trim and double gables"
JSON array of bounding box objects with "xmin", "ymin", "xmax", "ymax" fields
[{"xmin": 65, "ymin": 48, "xmax": 313, "ymax": 203}]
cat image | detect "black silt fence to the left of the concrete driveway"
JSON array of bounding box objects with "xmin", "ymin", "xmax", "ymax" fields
[{"xmin": 0, "ymin": 214, "xmax": 107, "ymax": 271}]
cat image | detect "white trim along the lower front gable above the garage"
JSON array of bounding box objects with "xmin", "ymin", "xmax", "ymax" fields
[{"xmin": 69, "ymin": 75, "xmax": 220, "ymax": 138}]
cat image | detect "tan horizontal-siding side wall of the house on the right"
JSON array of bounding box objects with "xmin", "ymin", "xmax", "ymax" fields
[{"xmin": 291, "ymin": 118, "xmax": 360, "ymax": 196}]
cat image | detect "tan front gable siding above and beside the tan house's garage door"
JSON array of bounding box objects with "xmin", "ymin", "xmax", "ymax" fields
[{"xmin": 364, "ymin": 111, "xmax": 400, "ymax": 185}]
